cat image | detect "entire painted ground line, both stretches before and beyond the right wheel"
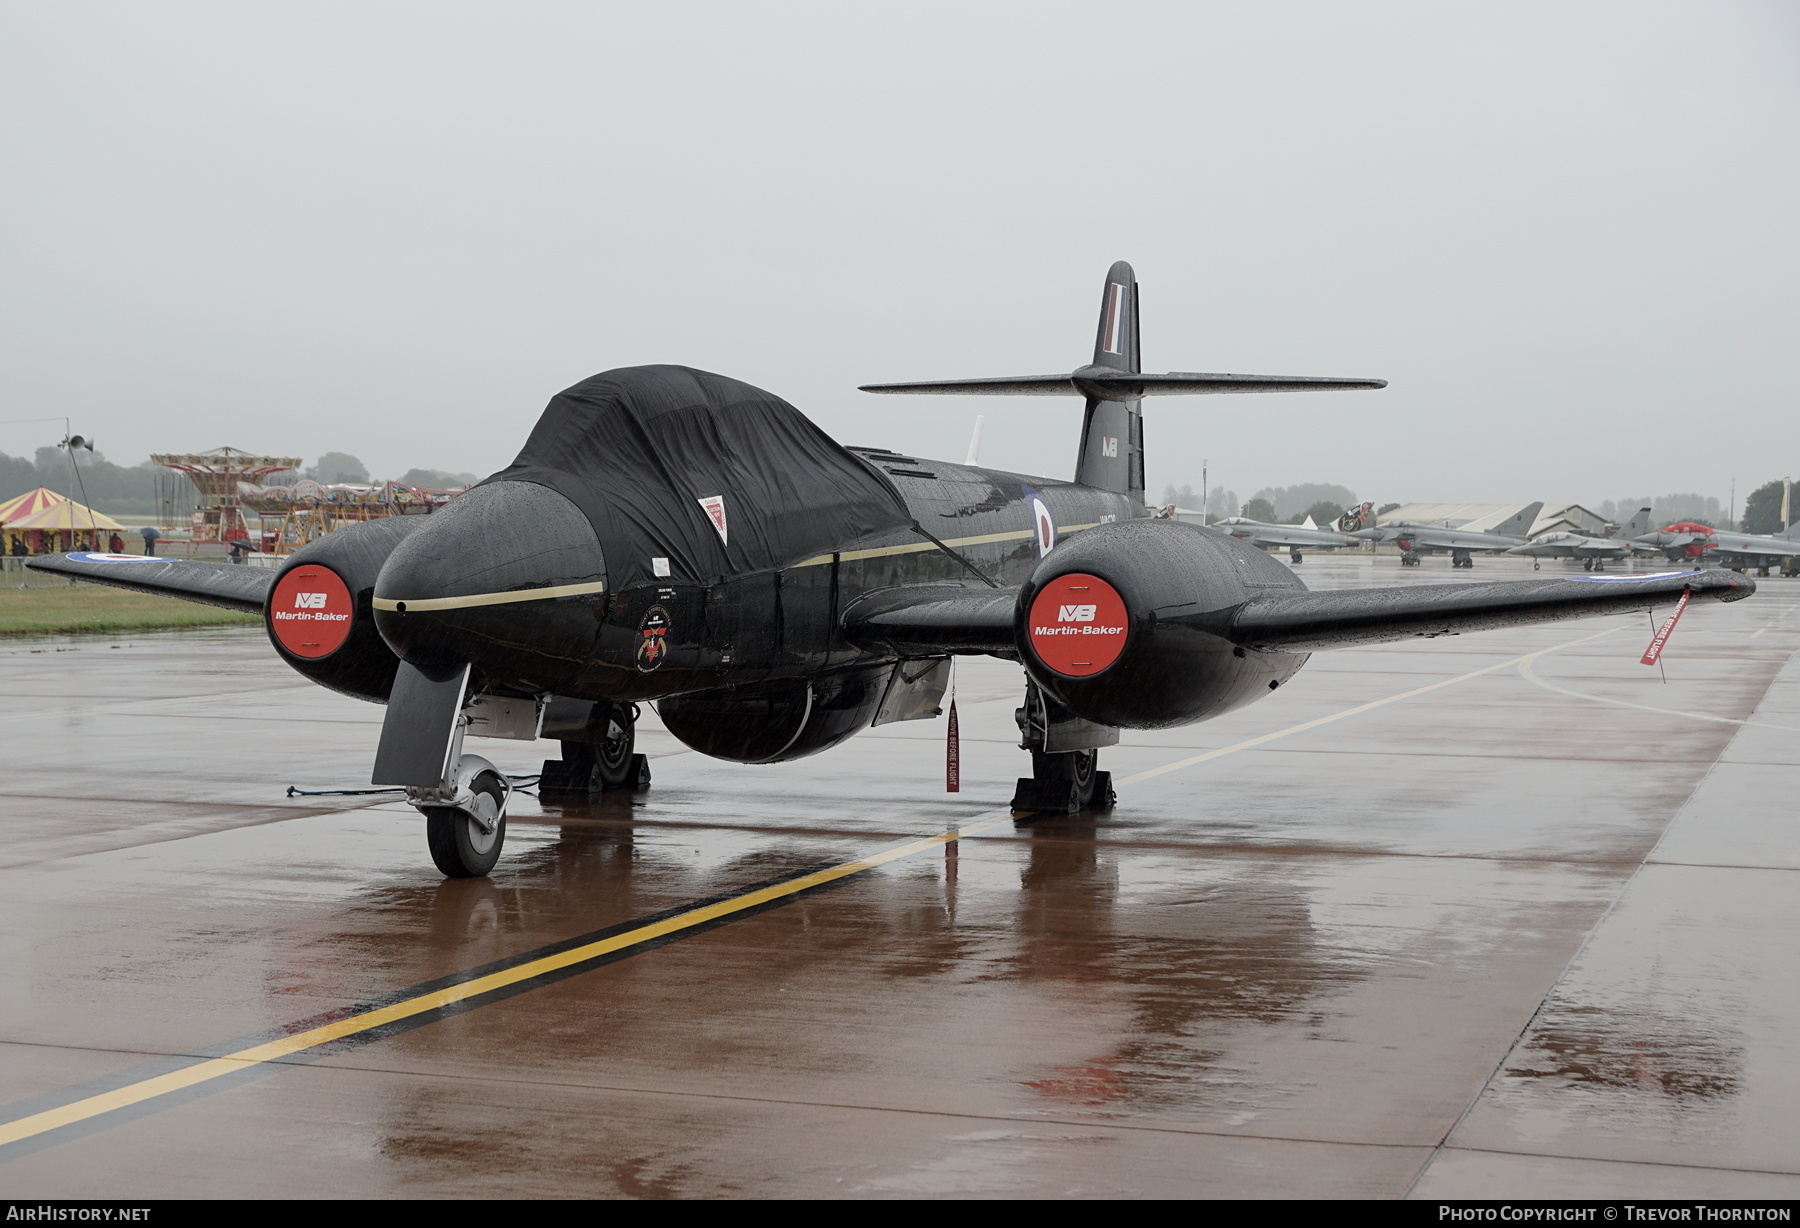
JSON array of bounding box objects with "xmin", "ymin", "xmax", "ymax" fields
[{"xmin": 0, "ymin": 627, "xmax": 1625, "ymax": 1158}]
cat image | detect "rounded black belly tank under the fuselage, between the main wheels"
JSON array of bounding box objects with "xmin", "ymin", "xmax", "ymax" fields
[{"xmin": 657, "ymin": 664, "xmax": 893, "ymax": 763}]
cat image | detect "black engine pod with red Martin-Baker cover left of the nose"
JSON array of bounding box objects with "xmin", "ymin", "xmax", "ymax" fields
[{"xmin": 263, "ymin": 517, "xmax": 427, "ymax": 704}]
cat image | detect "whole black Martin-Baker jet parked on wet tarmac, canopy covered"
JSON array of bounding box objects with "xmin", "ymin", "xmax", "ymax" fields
[{"xmin": 31, "ymin": 263, "xmax": 1755, "ymax": 877}]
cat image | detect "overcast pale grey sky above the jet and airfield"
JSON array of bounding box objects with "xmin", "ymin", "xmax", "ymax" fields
[{"xmin": 0, "ymin": 0, "xmax": 1800, "ymax": 501}]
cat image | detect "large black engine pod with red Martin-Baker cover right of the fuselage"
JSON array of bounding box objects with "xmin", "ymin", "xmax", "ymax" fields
[{"xmin": 1017, "ymin": 520, "xmax": 1307, "ymax": 729}]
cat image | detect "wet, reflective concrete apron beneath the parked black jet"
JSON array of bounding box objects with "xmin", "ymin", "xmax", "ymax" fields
[{"xmin": 0, "ymin": 558, "xmax": 1800, "ymax": 1197}]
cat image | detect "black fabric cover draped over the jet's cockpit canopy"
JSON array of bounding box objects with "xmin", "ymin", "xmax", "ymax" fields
[{"xmin": 486, "ymin": 366, "xmax": 913, "ymax": 589}]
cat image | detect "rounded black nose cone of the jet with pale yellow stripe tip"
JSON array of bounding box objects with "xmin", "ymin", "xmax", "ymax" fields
[{"xmin": 374, "ymin": 481, "xmax": 607, "ymax": 690}]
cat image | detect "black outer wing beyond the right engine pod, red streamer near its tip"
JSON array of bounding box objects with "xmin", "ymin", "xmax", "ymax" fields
[{"xmin": 1224, "ymin": 569, "xmax": 1757, "ymax": 652}]
